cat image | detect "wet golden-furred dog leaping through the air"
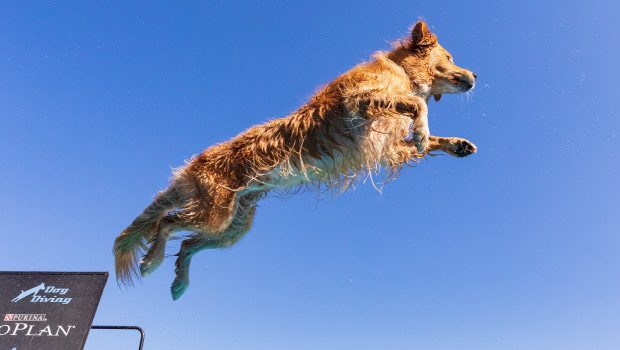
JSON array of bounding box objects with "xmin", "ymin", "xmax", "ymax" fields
[{"xmin": 113, "ymin": 21, "xmax": 476, "ymax": 300}]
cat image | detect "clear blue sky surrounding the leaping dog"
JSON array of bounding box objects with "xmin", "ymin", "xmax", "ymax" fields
[{"xmin": 0, "ymin": 1, "xmax": 620, "ymax": 350}]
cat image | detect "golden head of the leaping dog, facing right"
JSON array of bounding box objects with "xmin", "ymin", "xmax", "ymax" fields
[{"xmin": 388, "ymin": 21, "xmax": 476, "ymax": 101}]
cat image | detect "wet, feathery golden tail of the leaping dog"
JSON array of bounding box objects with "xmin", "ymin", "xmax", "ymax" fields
[{"xmin": 113, "ymin": 186, "xmax": 178, "ymax": 285}]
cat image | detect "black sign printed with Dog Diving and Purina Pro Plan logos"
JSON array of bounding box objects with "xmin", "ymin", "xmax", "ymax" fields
[{"xmin": 0, "ymin": 272, "xmax": 108, "ymax": 350}]
